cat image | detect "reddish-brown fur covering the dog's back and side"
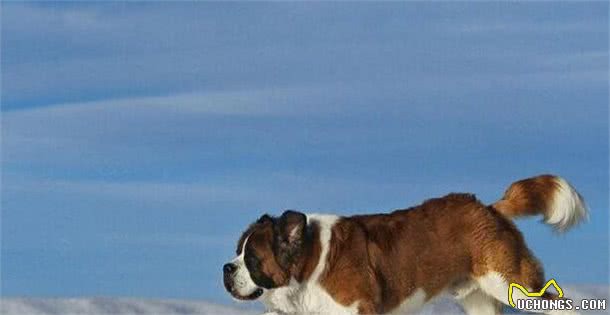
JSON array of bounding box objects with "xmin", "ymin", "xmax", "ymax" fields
[{"xmin": 314, "ymin": 194, "xmax": 542, "ymax": 314}]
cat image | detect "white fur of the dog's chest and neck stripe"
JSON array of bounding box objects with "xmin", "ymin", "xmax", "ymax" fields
[{"xmin": 261, "ymin": 214, "xmax": 358, "ymax": 315}]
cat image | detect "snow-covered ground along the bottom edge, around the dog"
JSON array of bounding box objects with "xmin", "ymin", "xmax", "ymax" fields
[{"xmin": 0, "ymin": 285, "xmax": 610, "ymax": 315}]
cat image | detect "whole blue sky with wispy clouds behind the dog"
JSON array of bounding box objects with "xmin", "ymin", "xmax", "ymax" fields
[{"xmin": 1, "ymin": 2, "xmax": 609, "ymax": 303}]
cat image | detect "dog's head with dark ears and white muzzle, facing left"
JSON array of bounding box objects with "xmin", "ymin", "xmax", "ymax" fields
[{"xmin": 223, "ymin": 210, "xmax": 307, "ymax": 300}]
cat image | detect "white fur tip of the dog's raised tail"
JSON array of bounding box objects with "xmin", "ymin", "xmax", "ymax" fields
[{"xmin": 546, "ymin": 177, "xmax": 589, "ymax": 232}]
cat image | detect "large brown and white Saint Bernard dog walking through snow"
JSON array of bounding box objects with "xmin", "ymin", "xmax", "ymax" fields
[{"xmin": 223, "ymin": 175, "xmax": 588, "ymax": 314}]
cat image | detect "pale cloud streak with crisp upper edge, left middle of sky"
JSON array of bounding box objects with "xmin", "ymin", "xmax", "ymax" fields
[{"xmin": 2, "ymin": 88, "xmax": 341, "ymax": 169}]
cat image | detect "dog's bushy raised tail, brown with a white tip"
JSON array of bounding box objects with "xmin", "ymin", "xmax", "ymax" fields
[{"xmin": 493, "ymin": 175, "xmax": 589, "ymax": 232}]
